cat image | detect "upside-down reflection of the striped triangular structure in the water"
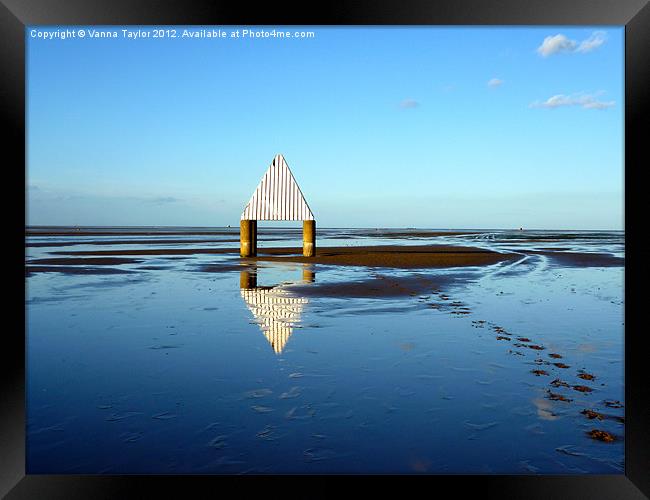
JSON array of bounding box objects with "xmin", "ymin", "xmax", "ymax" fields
[{"xmin": 240, "ymin": 266, "xmax": 314, "ymax": 354}]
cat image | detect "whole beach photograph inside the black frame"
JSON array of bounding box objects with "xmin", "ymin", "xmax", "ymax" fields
[{"xmin": 24, "ymin": 24, "xmax": 628, "ymax": 477}]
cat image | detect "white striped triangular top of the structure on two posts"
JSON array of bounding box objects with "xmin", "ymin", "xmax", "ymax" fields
[{"xmin": 241, "ymin": 155, "xmax": 314, "ymax": 220}]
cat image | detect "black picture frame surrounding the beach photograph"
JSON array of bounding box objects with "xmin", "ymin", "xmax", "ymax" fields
[{"xmin": 0, "ymin": 0, "xmax": 650, "ymax": 500}]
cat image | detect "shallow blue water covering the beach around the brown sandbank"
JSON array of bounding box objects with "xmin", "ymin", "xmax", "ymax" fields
[{"xmin": 26, "ymin": 228, "xmax": 625, "ymax": 474}]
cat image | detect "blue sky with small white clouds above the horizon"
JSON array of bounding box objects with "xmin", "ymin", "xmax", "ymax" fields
[{"xmin": 25, "ymin": 26, "xmax": 624, "ymax": 230}]
